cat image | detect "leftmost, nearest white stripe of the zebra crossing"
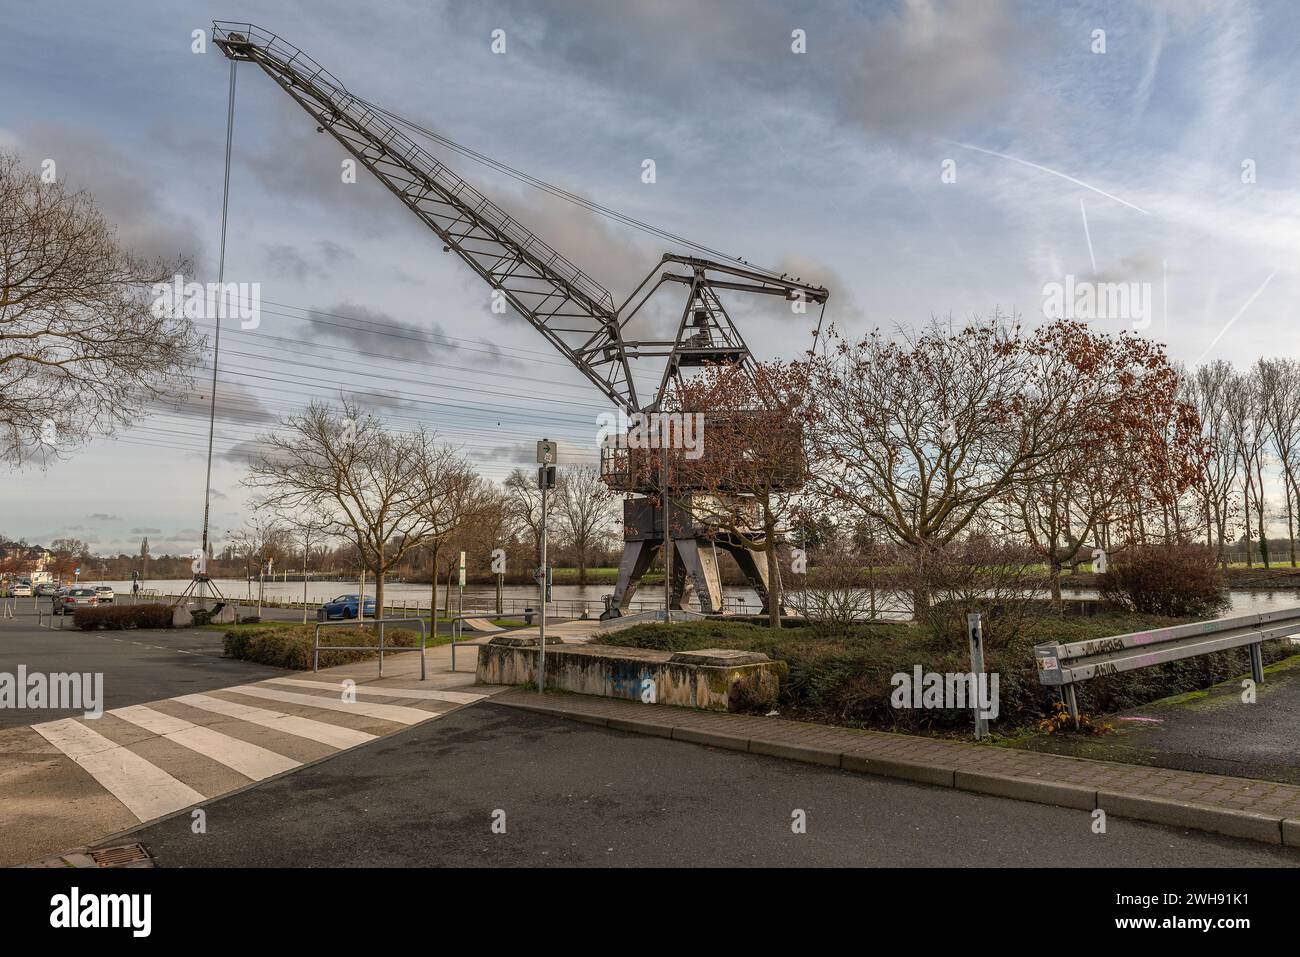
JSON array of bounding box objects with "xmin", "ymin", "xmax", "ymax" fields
[{"xmin": 31, "ymin": 718, "xmax": 203, "ymax": 820}]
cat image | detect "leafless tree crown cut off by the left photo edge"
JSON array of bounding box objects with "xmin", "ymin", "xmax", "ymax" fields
[{"xmin": 0, "ymin": 152, "xmax": 198, "ymax": 465}]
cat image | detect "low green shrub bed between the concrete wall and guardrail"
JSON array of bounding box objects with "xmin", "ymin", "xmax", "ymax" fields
[{"xmin": 599, "ymin": 614, "xmax": 1292, "ymax": 736}]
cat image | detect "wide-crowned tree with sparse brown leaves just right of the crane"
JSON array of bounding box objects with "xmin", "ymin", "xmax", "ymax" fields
[{"xmin": 810, "ymin": 315, "xmax": 1170, "ymax": 616}]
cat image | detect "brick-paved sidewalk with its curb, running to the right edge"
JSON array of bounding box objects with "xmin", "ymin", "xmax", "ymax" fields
[{"xmin": 493, "ymin": 690, "xmax": 1300, "ymax": 848}]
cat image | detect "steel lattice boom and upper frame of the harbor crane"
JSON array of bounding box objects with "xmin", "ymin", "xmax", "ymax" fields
[{"xmin": 212, "ymin": 21, "xmax": 827, "ymax": 412}]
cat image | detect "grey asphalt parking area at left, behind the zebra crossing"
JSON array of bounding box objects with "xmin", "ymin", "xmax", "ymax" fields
[{"xmin": 0, "ymin": 608, "xmax": 287, "ymax": 728}]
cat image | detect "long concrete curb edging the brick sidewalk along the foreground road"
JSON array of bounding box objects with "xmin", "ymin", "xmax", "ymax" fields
[{"xmin": 489, "ymin": 696, "xmax": 1300, "ymax": 848}]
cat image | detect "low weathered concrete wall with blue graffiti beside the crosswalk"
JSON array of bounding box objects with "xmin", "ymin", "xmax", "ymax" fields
[{"xmin": 477, "ymin": 636, "xmax": 784, "ymax": 711}]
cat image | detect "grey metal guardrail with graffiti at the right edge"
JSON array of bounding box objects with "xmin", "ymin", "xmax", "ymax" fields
[{"xmin": 1034, "ymin": 609, "xmax": 1300, "ymax": 724}]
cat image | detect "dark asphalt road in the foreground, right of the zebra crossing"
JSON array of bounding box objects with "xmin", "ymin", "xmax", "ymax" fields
[{"xmin": 124, "ymin": 702, "xmax": 1300, "ymax": 867}]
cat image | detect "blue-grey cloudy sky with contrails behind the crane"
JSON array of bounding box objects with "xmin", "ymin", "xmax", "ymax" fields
[{"xmin": 0, "ymin": 0, "xmax": 1300, "ymax": 553}]
